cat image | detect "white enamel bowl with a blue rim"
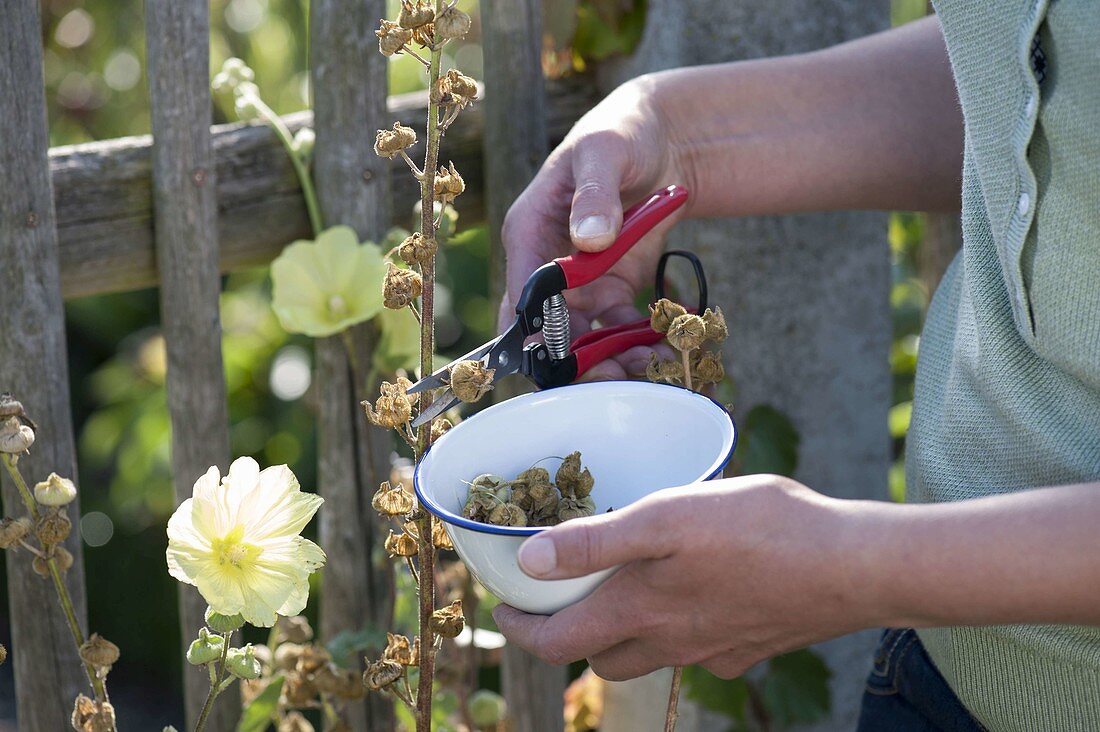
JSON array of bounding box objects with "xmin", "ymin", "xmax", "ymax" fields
[{"xmin": 413, "ymin": 381, "xmax": 736, "ymax": 614}]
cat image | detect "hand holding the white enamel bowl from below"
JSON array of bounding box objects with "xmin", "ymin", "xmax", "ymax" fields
[{"xmin": 494, "ymin": 476, "xmax": 884, "ymax": 680}]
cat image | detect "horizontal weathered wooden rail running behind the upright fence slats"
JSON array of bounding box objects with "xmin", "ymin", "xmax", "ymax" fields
[{"xmin": 51, "ymin": 80, "xmax": 593, "ymax": 298}]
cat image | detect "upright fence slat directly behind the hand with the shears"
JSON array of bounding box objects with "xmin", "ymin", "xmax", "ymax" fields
[{"xmin": 481, "ymin": 0, "xmax": 565, "ymax": 730}]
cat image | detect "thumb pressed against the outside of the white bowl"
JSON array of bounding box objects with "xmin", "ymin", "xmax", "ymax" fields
[{"xmin": 519, "ymin": 503, "xmax": 672, "ymax": 579}]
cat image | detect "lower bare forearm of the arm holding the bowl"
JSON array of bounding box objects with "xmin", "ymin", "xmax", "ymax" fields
[{"xmin": 842, "ymin": 483, "xmax": 1100, "ymax": 627}]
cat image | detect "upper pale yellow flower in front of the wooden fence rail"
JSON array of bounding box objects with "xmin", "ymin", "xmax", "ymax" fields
[{"xmin": 272, "ymin": 226, "xmax": 386, "ymax": 338}]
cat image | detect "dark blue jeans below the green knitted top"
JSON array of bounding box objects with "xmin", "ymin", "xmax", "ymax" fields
[{"xmin": 858, "ymin": 627, "xmax": 985, "ymax": 732}]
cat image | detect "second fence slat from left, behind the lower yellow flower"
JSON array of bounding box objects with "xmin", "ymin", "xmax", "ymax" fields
[{"xmin": 145, "ymin": 0, "xmax": 239, "ymax": 732}]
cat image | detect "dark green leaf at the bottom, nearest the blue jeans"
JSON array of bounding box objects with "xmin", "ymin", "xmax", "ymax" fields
[{"xmin": 760, "ymin": 649, "xmax": 832, "ymax": 728}]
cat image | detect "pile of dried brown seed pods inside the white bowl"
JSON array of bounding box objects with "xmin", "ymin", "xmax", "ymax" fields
[{"xmin": 462, "ymin": 452, "xmax": 596, "ymax": 526}]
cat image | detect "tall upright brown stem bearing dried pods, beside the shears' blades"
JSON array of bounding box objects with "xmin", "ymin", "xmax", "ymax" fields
[{"xmin": 416, "ymin": 0, "xmax": 442, "ymax": 732}]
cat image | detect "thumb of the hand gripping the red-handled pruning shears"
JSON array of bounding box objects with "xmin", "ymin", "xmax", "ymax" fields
[{"xmin": 569, "ymin": 134, "xmax": 628, "ymax": 252}]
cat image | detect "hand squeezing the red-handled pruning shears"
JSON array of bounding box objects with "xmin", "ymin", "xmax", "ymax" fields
[{"xmin": 501, "ymin": 77, "xmax": 691, "ymax": 379}]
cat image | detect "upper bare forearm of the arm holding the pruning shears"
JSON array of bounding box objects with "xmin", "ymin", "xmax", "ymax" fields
[{"xmin": 640, "ymin": 18, "xmax": 963, "ymax": 216}]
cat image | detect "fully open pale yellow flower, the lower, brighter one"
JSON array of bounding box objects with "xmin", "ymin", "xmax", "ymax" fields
[{"xmin": 167, "ymin": 458, "xmax": 325, "ymax": 627}]
